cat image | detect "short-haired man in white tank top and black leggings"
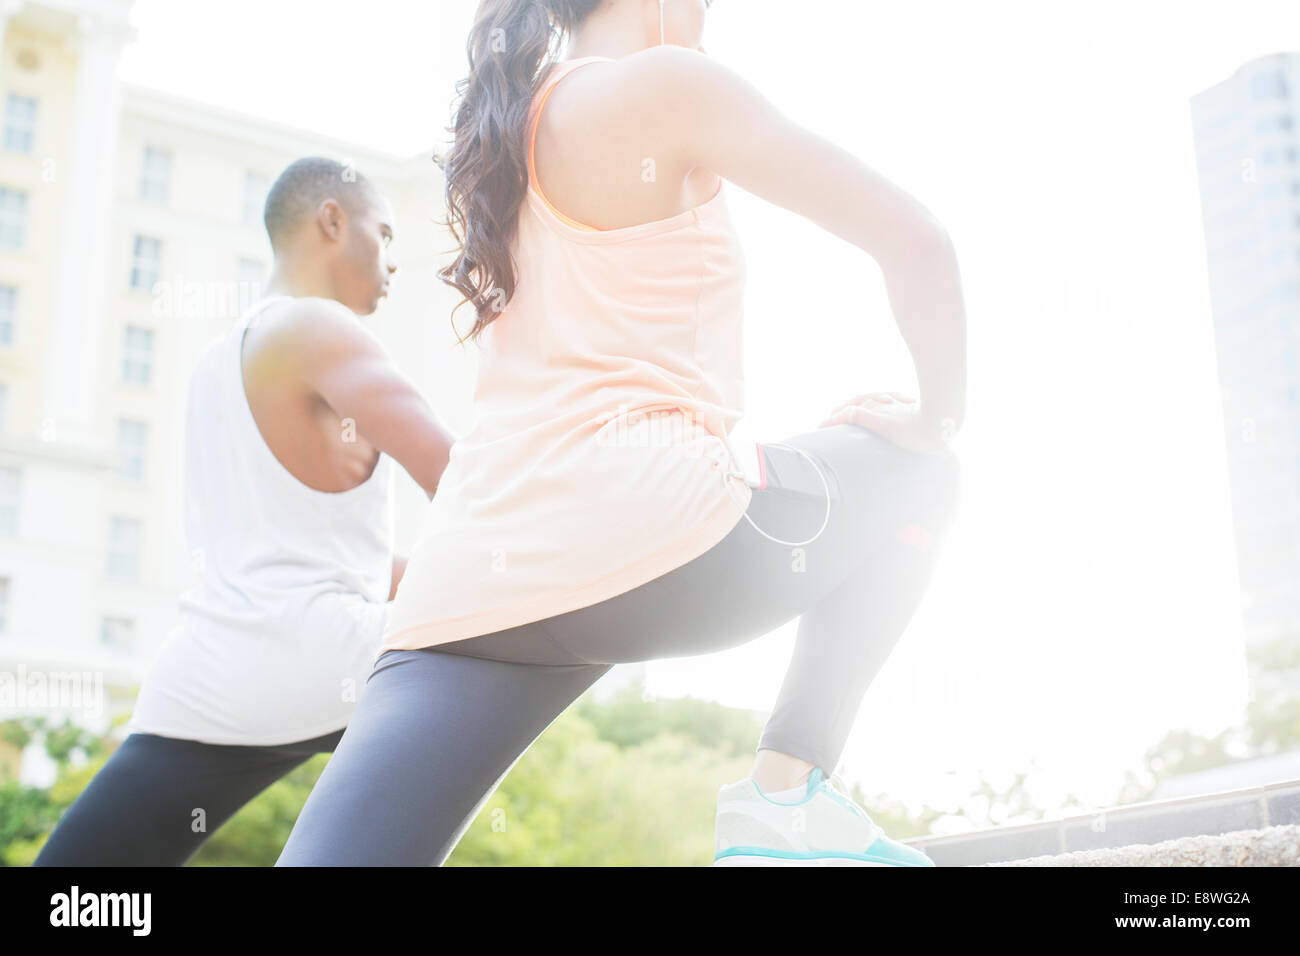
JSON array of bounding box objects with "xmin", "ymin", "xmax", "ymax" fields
[{"xmin": 36, "ymin": 157, "xmax": 452, "ymax": 865}]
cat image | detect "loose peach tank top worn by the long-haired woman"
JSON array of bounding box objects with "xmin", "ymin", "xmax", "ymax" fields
[{"xmin": 382, "ymin": 57, "xmax": 753, "ymax": 650}]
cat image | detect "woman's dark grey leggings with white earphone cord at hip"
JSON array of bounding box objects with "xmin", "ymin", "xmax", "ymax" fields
[{"xmin": 277, "ymin": 424, "xmax": 961, "ymax": 866}]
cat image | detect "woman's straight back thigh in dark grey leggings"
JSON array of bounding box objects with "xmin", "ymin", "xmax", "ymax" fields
[{"xmin": 277, "ymin": 648, "xmax": 608, "ymax": 866}]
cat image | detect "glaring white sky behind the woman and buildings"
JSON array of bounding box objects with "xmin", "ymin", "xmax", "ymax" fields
[{"xmin": 124, "ymin": 0, "xmax": 1300, "ymax": 806}]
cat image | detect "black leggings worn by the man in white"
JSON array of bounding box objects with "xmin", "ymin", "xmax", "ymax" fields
[{"xmin": 34, "ymin": 730, "xmax": 343, "ymax": 866}]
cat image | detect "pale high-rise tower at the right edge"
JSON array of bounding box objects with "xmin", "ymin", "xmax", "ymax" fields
[{"xmin": 1191, "ymin": 53, "xmax": 1300, "ymax": 691}]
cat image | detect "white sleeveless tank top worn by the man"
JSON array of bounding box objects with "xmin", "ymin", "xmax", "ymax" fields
[{"xmin": 127, "ymin": 295, "xmax": 393, "ymax": 745}]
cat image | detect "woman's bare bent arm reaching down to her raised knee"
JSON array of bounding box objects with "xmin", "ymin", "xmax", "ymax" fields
[{"xmin": 624, "ymin": 47, "xmax": 966, "ymax": 434}]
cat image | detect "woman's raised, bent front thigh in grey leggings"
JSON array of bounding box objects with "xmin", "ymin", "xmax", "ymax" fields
[{"xmin": 538, "ymin": 425, "xmax": 958, "ymax": 663}]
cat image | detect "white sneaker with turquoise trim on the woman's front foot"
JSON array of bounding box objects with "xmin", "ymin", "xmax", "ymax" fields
[{"xmin": 714, "ymin": 767, "xmax": 935, "ymax": 866}]
